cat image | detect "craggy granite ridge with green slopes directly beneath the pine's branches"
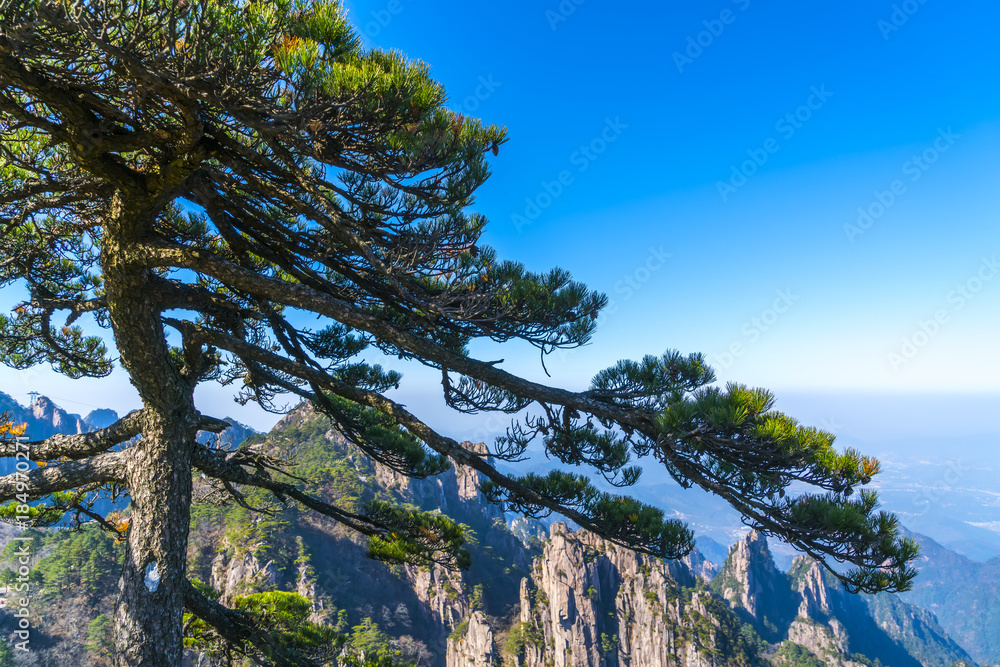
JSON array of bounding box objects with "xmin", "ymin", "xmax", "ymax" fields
[{"xmin": 0, "ymin": 406, "xmax": 988, "ymax": 667}]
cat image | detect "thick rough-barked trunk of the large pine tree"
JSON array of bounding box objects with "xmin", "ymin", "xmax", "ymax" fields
[{"xmin": 101, "ymin": 194, "xmax": 198, "ymax": 667}]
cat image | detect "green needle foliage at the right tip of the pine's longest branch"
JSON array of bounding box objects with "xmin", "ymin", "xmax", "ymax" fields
[{"xmin": 656, "ymin": 383, "xmax": 918, "ymax": 592}]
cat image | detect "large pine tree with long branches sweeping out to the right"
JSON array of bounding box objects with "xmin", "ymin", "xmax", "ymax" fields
[{"xmin": 0, "ymin": 0, "xmax": 915, "ymax": 667}]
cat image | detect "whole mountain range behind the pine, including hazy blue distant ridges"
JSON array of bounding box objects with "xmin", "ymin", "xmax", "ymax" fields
[{"xmin": 0, "ymin": 394, "xmax": 1000, "ymax": 667}]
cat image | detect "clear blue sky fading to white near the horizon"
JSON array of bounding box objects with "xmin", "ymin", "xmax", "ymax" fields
[{"xmin": 0, "ymin": 0, "xmax": 1000, "ymax": 448}]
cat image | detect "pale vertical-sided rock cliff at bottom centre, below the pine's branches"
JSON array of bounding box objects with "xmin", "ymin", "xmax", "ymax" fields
[{"xmin": 448, "ymin": 523, "xmax": 759, "ymax": 667}]
